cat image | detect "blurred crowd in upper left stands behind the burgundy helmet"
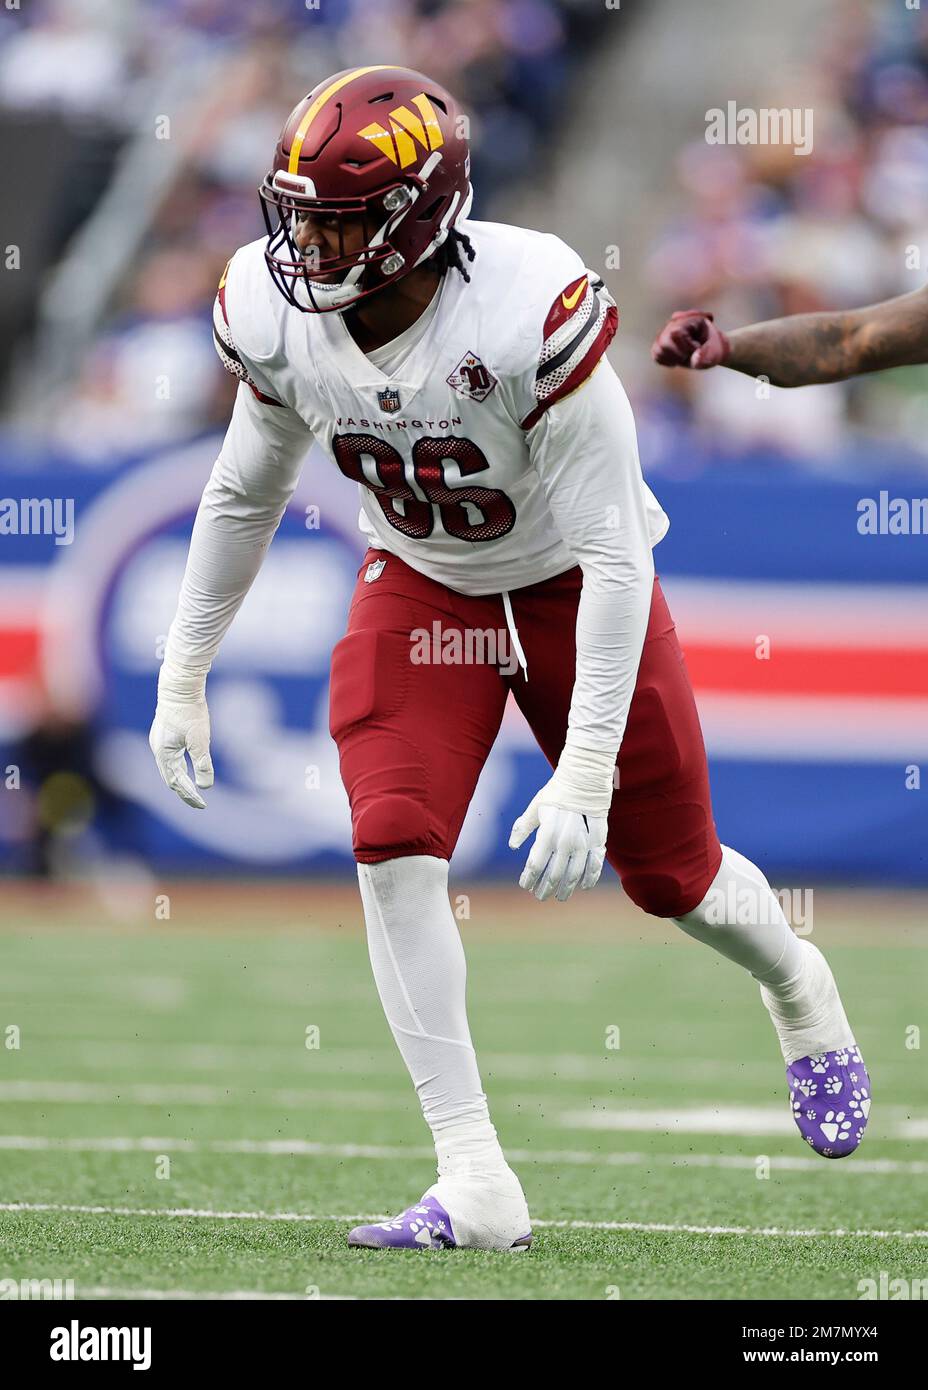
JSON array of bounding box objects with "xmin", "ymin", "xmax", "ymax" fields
[{"xmin": 0, "ymin": 0, "xmax": 604, "ymax": 464}]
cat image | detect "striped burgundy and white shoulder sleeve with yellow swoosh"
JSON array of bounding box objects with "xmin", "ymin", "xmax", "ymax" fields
[{"xmin": 521, "ymin": 270, "xmax": 618, "ymax": 430}]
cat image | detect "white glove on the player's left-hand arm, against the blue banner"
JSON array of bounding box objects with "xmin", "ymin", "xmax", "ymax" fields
[{"xmin": 149, "ymin": 660, "xmax": 213, "ymax": 810}]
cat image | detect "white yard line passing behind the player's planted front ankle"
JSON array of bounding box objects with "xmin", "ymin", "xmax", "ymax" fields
[{"xmin": 0, "ymin": 1134, "xmax": 928, "ymax": 1176}]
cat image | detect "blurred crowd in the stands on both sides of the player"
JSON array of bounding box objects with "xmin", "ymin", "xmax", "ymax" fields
[{"xmin": 0, "ymin": 0, "xmax": 928, "ymax": 466}]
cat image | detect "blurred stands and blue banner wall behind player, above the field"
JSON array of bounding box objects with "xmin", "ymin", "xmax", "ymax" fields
[{"xmin": 0, "ymin": 0, "xmax": 928, "ymax": 884}]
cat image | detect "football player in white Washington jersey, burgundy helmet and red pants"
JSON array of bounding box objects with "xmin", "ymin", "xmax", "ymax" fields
[{"xmin": 150, "ymin": 65, "xmax": 868, "ymax": 1250}]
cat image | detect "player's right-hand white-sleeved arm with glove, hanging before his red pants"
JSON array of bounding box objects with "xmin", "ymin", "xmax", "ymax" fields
[{"xmin": 510, "ymin": 361, "xmax": 654, "ymax": 901}]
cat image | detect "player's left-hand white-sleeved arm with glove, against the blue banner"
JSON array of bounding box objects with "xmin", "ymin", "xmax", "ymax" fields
[{"xmin": 149, "ymin": 381, "xmax": 311, "ymax": 810}]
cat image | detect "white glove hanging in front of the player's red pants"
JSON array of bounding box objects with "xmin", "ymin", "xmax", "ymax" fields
[{"xmin": 508, "ymin": 745, "xmax": 615, "ymax": 902}]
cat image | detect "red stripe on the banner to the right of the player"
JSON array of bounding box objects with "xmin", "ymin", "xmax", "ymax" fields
[{"xmin": 683, "ymin": 641, "xmax": 928, "ymax": 698}]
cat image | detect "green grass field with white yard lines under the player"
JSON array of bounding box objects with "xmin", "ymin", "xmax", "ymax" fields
[{"xmin": 0, "ymin": 883, "xmax": 928, "ymax": 1300}]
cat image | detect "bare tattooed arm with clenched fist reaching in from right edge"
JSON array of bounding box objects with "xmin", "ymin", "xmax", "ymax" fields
[{"xmin": 652, "ymin": 286, "xmax": 928, "ymax": 386}]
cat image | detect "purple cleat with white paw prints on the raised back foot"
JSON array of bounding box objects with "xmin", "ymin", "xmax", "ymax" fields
[{"xmin": 786, "ymin": 1044, "xmax": 870, "ymax": 1158}]
